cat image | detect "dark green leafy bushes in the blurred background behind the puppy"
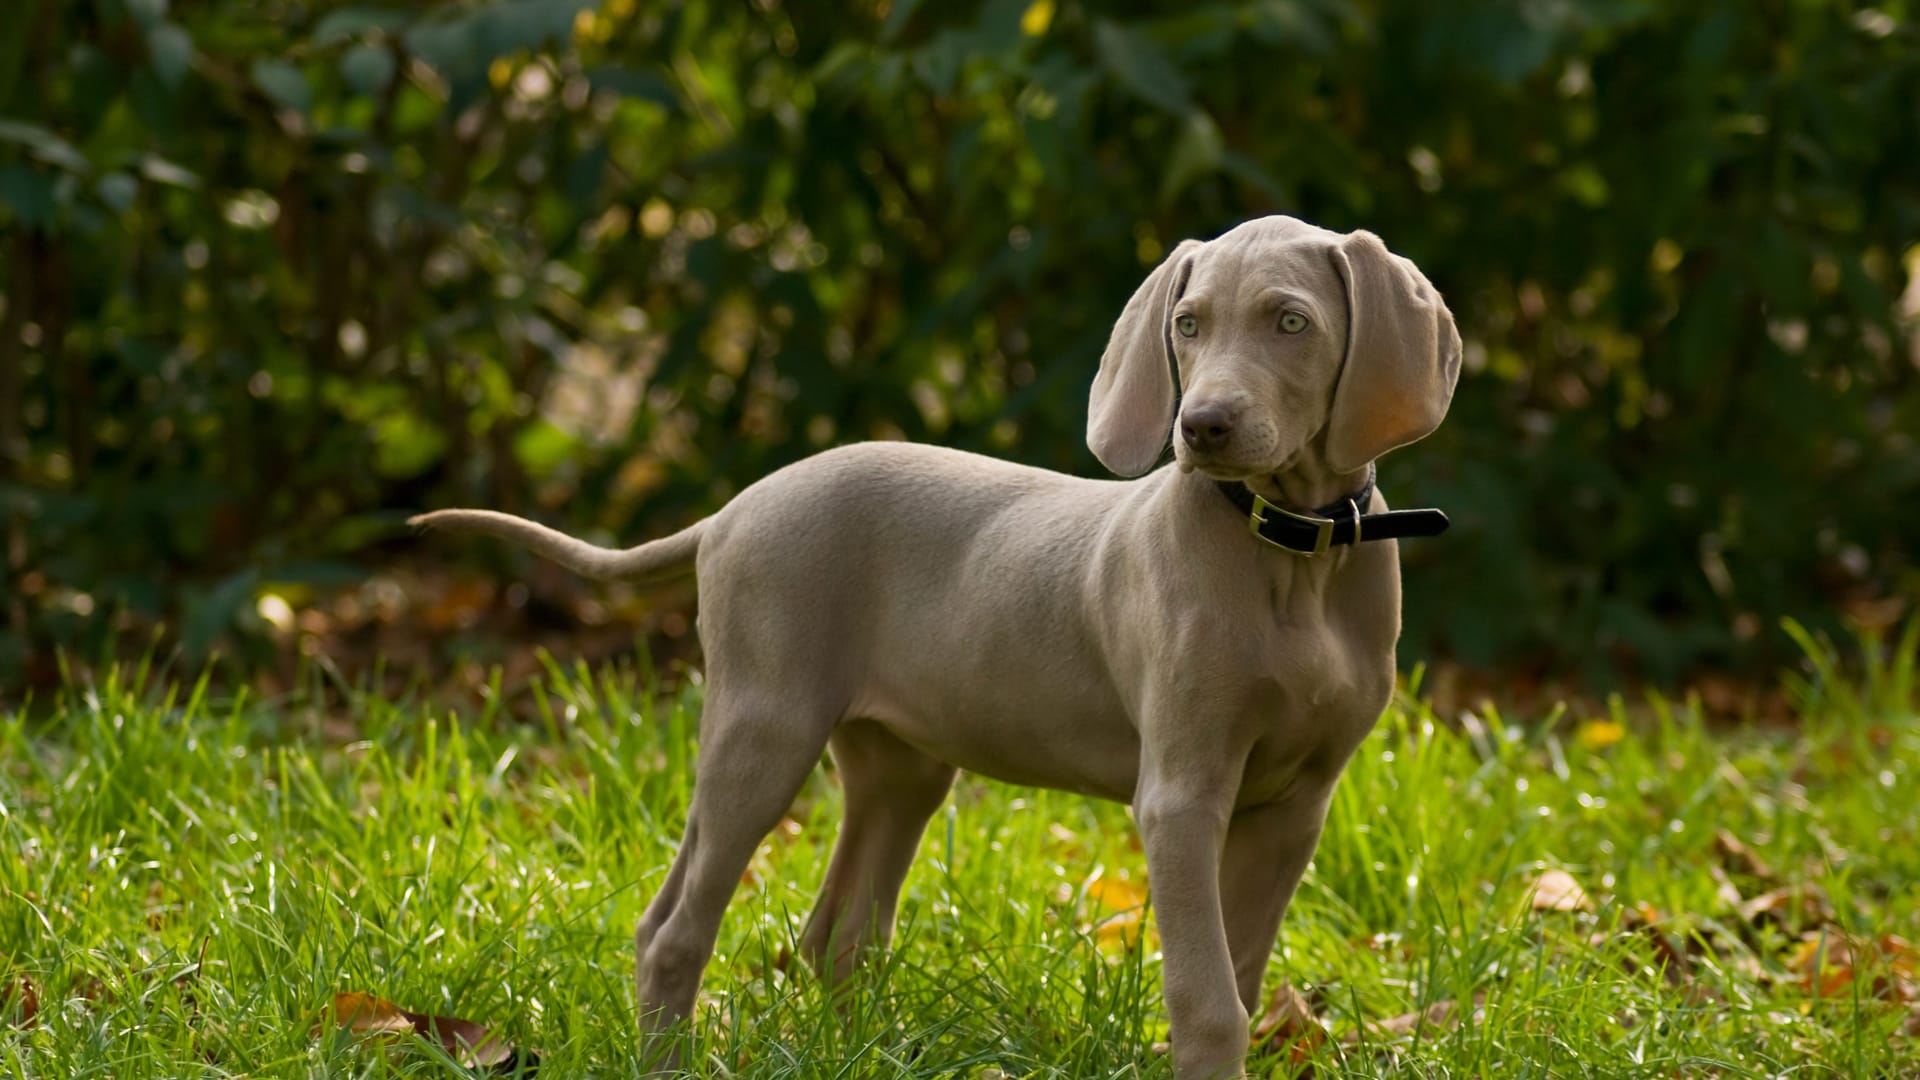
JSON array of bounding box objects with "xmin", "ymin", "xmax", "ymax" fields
[{"xmin": 0, "ymin": 0, "xmax": 1920, "ymax": 688}]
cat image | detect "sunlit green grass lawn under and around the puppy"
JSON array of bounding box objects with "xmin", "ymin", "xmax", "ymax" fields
[{"xmin": 0, "ymin": 622, "xmax": 1920, "ymax": 1078}]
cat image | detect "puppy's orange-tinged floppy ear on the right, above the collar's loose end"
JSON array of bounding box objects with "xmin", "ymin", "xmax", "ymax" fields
[{"xmin": 1327, "ymin": 231, "xmax": 1459, "ymax": 473}]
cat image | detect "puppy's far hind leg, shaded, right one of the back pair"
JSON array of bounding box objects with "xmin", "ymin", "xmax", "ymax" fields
[{"xmin": 801, "ymin": 721, "xmax": 954, "ymax": 984}]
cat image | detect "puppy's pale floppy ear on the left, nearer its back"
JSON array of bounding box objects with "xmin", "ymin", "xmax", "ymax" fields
[{"xmin": 1087, "ymin": 240, "xmax": 1206, "ymax": 477}]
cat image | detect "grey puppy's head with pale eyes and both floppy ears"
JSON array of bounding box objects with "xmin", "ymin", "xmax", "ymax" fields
[{"xmin": 1087, "ymin": 217, "xmax": 1461, "ymax": 480}]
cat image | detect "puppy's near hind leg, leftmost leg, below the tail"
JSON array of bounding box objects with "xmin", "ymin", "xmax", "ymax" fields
[{"xmin": 634, "ymin": 684, "xmax": 835, "ymax": 1068}]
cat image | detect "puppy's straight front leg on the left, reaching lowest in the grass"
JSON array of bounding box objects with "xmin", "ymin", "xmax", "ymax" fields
[{"xmin": 1135, "ymin": 761, "xmax": 1248, "ymax": 1080}]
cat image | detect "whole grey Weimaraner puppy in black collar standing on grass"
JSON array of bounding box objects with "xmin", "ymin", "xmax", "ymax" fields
[{"xmin": 415, "ymin": 217, "xmax": 1461, "ymax": 1080}]
